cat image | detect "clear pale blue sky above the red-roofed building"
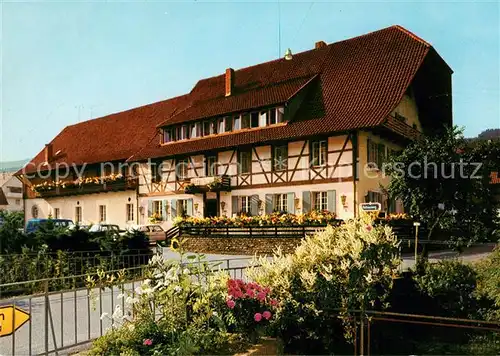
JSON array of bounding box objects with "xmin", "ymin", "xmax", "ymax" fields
[{"xmin": 0, "ymin": 0, "xmax": 500, "ymax": 161}]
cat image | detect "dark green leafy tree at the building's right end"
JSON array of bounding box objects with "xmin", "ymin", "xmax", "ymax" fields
[{"xmin": 384, "ymin": 127, "xmax": 500, "ymax": 248}]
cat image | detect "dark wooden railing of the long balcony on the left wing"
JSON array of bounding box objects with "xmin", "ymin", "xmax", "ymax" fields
[{"xmin": 30, "ymin": 178, "xmax": 139, "ymax": 198}]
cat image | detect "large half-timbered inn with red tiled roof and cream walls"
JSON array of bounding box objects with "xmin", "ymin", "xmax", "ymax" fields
[{"xmin": 19, "ymin": 26, "xmax": 452, "ymax": 227}]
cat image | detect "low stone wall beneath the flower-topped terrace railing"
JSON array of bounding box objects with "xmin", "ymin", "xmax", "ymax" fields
[{"xmin": 183, "ymin": 237, "xmax": 301, "ymax": 256}]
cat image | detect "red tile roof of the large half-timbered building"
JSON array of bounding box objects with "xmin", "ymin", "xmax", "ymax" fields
[{"xmin": 18, "ymin": 26, "xmax": 452, "ymax": 173}]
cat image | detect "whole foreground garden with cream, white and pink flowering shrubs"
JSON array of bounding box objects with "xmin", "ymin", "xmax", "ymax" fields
[{"xmin": 88, "ymin": 216, "xmax": 500, "ymax": 355}]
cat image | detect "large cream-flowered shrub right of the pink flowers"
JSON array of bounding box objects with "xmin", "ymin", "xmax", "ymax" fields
[{"xmin": 249, "ymin": 216, "xmax": 400, "ymax": 353}]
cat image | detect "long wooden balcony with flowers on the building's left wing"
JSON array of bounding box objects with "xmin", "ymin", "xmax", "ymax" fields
[{"xmin": 31, "ymin": 177, "xmax": 139, "ymax": 198}]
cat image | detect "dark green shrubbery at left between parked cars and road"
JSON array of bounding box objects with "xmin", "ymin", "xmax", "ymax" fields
[{"xmin": 0, "ymin": 213, "xmax": 153, "ymax": 296}]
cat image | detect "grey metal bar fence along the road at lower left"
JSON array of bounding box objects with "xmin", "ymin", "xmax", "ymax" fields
[{"xmin": 0, "ymin": 259, "xmax": 252, "ymax": 355}]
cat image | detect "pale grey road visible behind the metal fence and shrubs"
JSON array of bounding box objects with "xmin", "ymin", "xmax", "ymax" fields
[{"xmin": 0, "ymin": 249, "xmax": 491, "ymax": 355}]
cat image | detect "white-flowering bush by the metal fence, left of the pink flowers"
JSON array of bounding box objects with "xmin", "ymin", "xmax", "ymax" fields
[{"xmin": 89, "ymin": 255, "xmax": 250, "ymax": 355}]
